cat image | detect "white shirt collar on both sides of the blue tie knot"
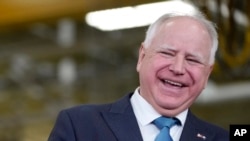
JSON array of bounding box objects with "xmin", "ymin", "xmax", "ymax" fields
[{"xmin": 131, "ymin": 87, "xmax": 188, "ymax": 126}]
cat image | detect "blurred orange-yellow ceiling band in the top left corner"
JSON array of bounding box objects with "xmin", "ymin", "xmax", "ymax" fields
[{"xmin": 0, "ymin": 0, "xmax": 160, "ymax": 31}]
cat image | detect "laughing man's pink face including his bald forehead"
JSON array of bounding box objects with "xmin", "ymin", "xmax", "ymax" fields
[{"xmin": 137, "ymin": 17, "xmax": 212, "ymax": 116}]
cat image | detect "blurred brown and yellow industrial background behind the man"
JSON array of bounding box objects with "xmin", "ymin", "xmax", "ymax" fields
[{"xmin": 0, "ymin": 0, "xmax": 250, "ymax": 141}]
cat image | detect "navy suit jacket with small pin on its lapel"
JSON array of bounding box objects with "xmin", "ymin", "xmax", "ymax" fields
[{"xmin": 48, "ymin": 94, "xmax": 229, "ymax": 141}]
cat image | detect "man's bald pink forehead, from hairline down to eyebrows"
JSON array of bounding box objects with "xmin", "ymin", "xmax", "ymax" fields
[{"xmin": 152, "ymin": 17, "xmax": 212, "ymax": 60}]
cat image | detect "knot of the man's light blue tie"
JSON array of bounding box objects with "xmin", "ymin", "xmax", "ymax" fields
[{"xmin": 153, "ymin": 117, "xmax": 179, "ymax": 129}]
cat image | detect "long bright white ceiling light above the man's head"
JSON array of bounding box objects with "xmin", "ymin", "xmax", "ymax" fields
[{"xmin": 85, "ymin": 1, "xmax": 194, "ymax": 31}]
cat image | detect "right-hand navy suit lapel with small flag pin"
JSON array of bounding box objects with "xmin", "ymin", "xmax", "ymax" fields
[{"xmin": 180, "ymin": 111, "xmax": 214, "ymax": 141}]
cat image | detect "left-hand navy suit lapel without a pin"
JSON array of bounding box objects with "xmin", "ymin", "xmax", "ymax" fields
[{"xmin": 103, "ymin": 95, "xmax": 142, "ymax": 141}]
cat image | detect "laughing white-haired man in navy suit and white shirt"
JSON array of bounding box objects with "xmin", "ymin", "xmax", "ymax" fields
[{"xmin": 49, "ymin": 1, "xmax": 229, "ymax": 141}]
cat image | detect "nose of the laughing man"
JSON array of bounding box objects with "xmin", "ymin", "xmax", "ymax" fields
[{"xmin": 169, "ymin": 56, "xmax": 185, "ymax": 75}]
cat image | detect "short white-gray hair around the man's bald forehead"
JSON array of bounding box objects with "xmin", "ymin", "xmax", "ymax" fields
[{"xmin": 144, "ymin": 9, "xmax": 218, "ymax": 65}]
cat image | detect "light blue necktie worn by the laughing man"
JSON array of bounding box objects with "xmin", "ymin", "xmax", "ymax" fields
[{"xmin": 153, "ymin": 117, "xmax": 178, "ymax": 141}]
